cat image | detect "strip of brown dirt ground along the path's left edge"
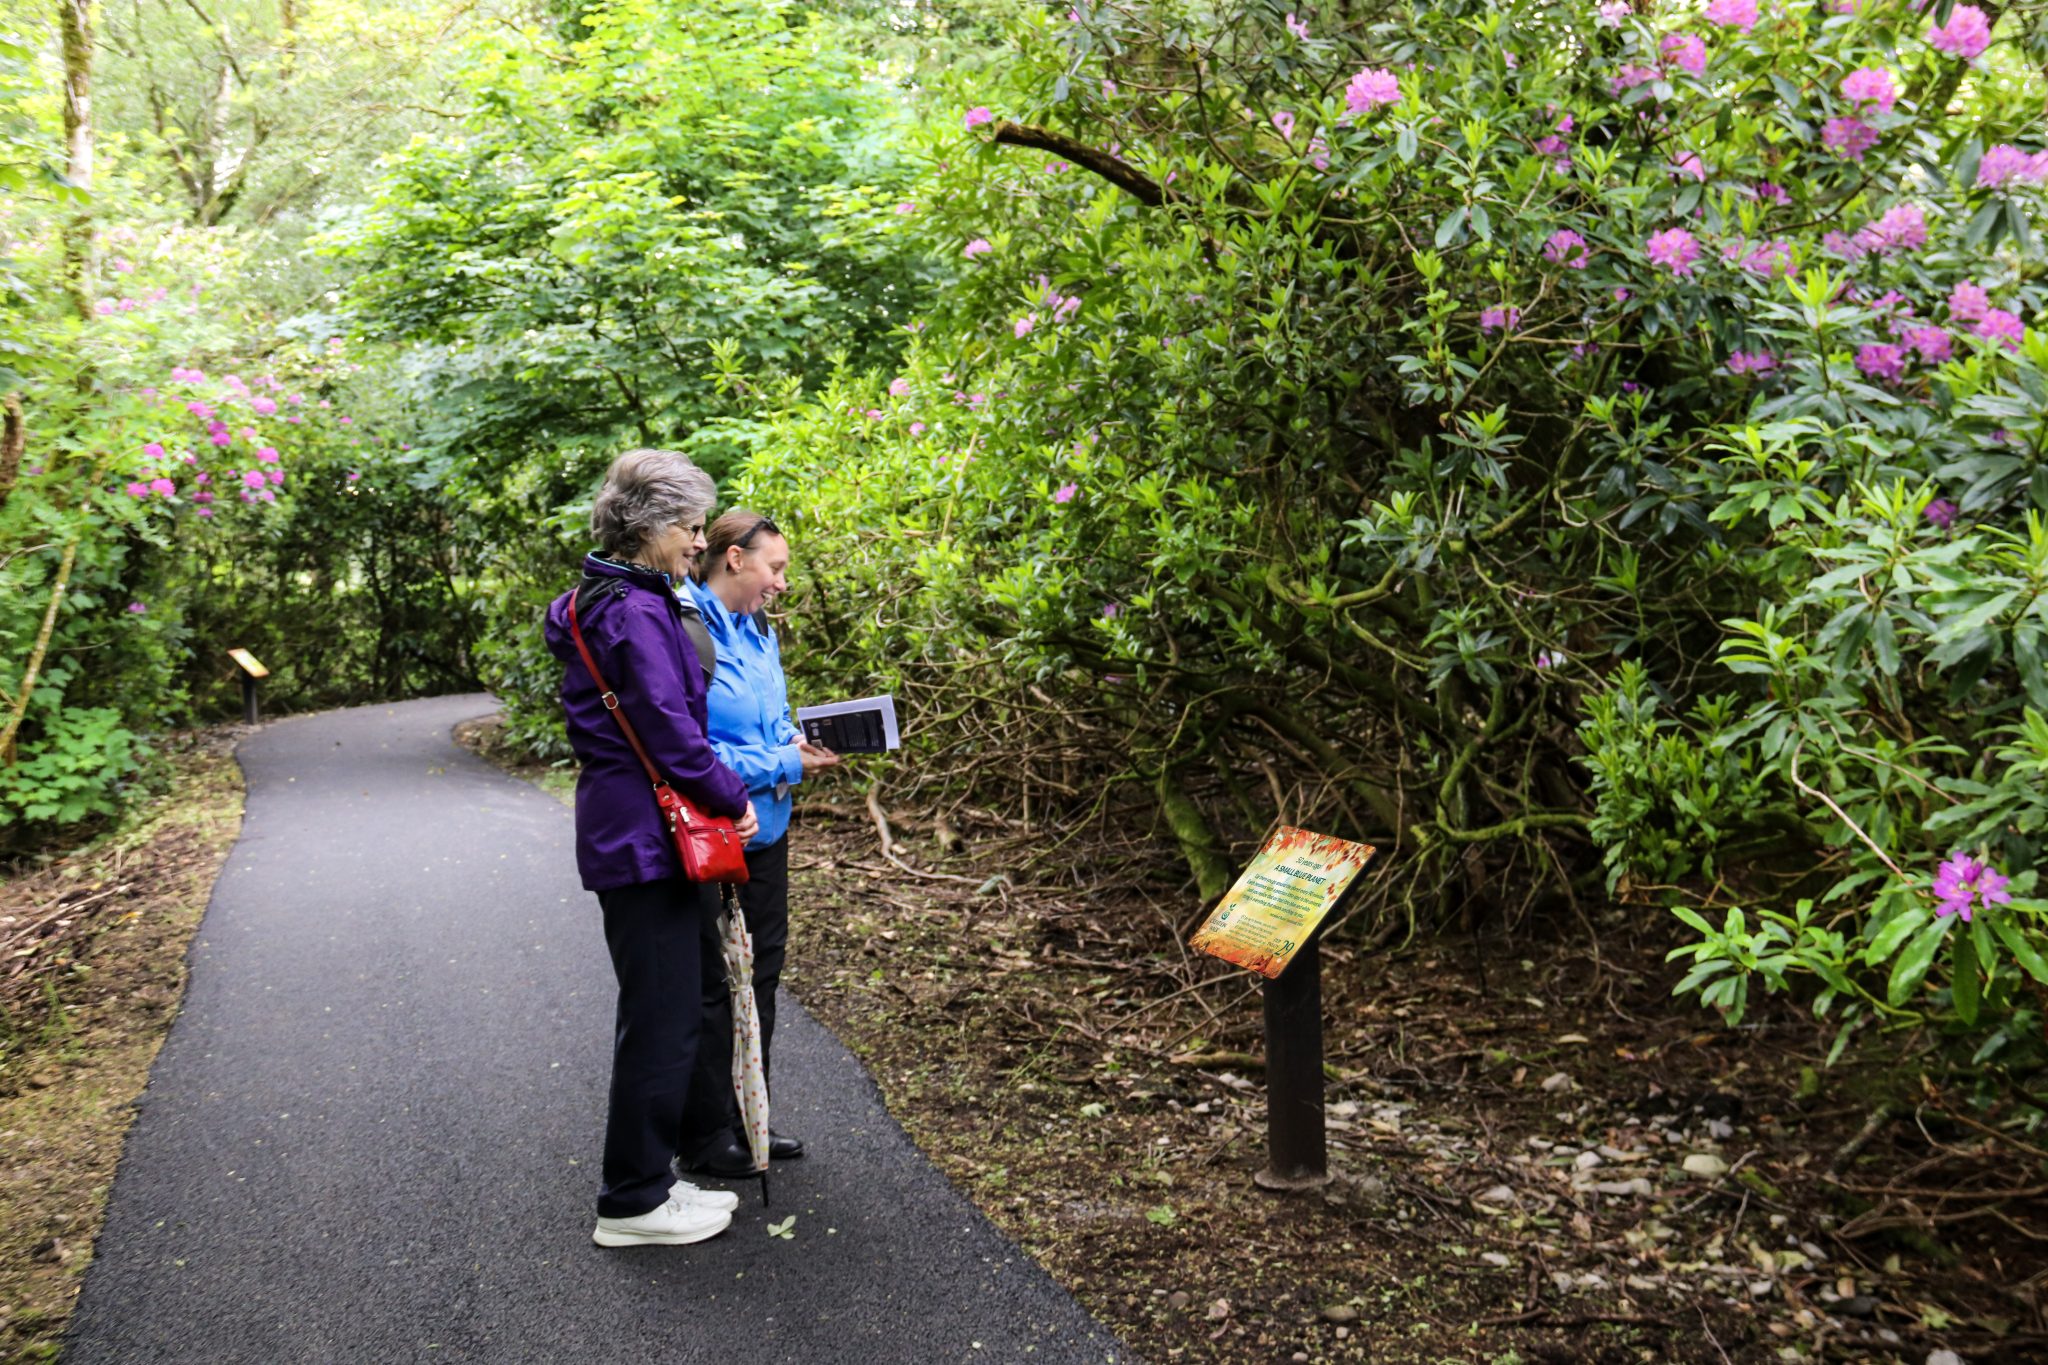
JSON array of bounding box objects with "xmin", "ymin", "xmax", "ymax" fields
[{"xmin": 0, "ymin": 726, "xmax": 242, "ymax": 1363}]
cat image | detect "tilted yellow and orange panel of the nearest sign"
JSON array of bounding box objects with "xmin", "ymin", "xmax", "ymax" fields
[{"xmin": 1192, "ymin": 825, "xmax": 1372, "ymax": 976}]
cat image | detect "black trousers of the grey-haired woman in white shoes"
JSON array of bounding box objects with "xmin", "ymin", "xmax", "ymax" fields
[{"xmin": 598, "ymin": 878, "xmax": 731, "ymax": 1218}]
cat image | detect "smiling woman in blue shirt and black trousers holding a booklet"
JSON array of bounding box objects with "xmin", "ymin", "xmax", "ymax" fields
[{"xmin": 680, "ymin": 508, "xmax": 840, "ymax": 1177}]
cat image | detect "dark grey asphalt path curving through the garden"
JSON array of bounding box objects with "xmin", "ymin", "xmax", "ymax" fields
[{"xmin": 63, "ymin": 696, "xmax": 1135, "ymax": 1365}]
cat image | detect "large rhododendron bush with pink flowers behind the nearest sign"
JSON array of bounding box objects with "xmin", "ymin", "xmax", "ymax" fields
[{"xmin": 727, "ymin": 0, "xmax": 2048, "ymax": 1058}]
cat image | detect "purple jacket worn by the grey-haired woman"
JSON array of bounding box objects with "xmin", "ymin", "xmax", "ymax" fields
[{"xmin": 545, "ymin": 555, "xmax": 748, "ymax": 890}]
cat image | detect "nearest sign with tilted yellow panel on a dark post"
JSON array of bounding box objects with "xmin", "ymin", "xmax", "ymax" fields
[{"xmin": 1192, "ymin": 825, "xmax": 1372, "ymax": 1189}]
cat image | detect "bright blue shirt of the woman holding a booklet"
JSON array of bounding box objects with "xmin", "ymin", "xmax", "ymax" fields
[{"xmin": 686, "ymin": 579, "xmax": 803, "ymax": 849}]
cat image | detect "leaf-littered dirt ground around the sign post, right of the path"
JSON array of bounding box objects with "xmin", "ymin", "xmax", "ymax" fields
[{"xmin": 770, "ymin": 819, "xmax": 2048, "ymax": 1365}]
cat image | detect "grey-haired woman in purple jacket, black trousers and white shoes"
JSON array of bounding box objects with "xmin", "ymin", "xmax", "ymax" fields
[{"xmin": 545, "ymin": 450, "xmax": 760, "ymax": 1246}]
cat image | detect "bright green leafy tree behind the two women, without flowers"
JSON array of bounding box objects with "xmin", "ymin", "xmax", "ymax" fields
[{"xmin": 326, "ymin": 0, "xmax": 926, "ymax": 755}]
